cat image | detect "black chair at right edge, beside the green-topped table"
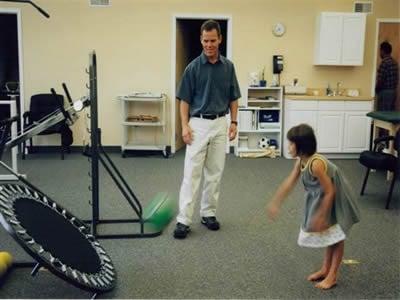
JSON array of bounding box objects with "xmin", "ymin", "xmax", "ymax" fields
[{"xmin": 359, "ymin": 130, "xmax": 400, "ymax": 209}]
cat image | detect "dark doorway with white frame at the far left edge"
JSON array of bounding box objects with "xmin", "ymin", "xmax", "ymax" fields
[{"xmin": 0, "ymin": 8, "xmax": 24, "ymax": 125}]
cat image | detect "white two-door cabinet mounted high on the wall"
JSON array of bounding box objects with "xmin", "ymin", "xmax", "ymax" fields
[{"xmin": 314, "ymin": 12, "xmax": 366, "ymax": 66}]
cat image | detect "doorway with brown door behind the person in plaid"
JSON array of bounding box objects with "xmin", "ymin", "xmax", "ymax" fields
[{"xmin": 372, "ymin": 19, "xmax": 400, "ymax": 111}]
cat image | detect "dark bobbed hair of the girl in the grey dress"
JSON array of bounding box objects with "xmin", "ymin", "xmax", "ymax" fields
[{"xmin": 286, "ymin": 124, "xmax": 317, "ymax": 156}]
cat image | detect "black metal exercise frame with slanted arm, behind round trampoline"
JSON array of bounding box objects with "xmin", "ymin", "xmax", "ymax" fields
[{"xmin": 0, "ymin": 51, "xmax": 166, "ymax": 239}]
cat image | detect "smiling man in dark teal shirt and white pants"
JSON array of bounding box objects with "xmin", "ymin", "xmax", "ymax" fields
[{"xmin": 174, "ymin": 20, "xmax": 241, "ymax": 239}]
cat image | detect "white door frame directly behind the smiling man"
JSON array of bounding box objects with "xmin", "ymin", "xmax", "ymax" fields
[{"xmin": 170, "ymin": 14, "xmax": 232, "ymax": 153}]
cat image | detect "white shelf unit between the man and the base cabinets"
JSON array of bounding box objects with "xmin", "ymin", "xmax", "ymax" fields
[{"xmin": 235, "ymin": 87, "xmax": 283, "ymax": 156}]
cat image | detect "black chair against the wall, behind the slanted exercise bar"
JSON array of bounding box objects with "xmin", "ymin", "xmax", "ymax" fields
[{"xmin": 22, "ymin": 94, "xmax": 73, "ymax": 159}]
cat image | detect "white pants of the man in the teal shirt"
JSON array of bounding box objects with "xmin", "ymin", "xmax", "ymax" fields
[{"xmin": 176, "ymin": 117, "xmax": 227, "ymax": 226}]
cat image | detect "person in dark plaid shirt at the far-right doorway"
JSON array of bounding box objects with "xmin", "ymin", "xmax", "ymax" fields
[{"xmin": 375, "ymin": 42, "xmax": 399, "ymax": 110}]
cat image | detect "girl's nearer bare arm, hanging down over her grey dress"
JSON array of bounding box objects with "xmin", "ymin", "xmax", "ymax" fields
[{"xmin": 311, "ymin": 159, "xmax": 335, "ymax": 232}]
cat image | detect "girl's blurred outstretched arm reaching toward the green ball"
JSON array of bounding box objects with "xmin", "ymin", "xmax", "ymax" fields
[{"xmin": 267, "ymin": 159, "xmax": 301, "ymax": 220}]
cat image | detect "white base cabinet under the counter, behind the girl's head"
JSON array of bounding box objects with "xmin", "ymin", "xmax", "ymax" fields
[{"xmin": 284, "ymin": 98, "xmax": 372, "ymax": 158}]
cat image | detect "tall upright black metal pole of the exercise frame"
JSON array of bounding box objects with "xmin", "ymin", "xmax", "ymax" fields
[{"xmin": 89, "ymin": 51, "xmax": 100, "ymax": 236}]
